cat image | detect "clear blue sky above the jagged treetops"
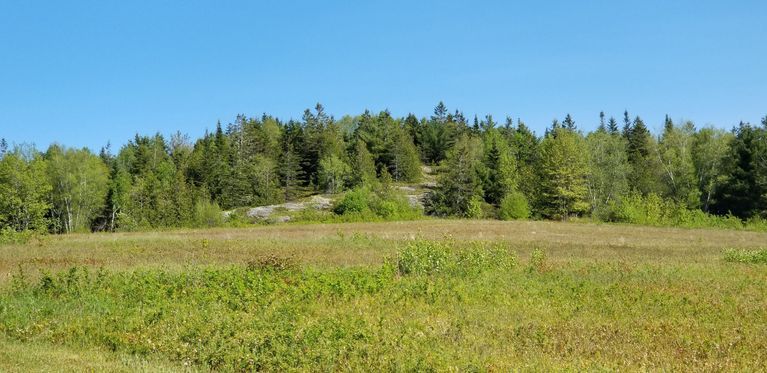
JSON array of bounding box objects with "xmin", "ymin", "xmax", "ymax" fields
[{"xmin": 0, "ymin": 0, "xmax": 767, "ymax": 150}]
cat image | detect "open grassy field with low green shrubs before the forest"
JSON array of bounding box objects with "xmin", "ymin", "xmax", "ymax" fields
[{"xmin": 0, "ymin": 220, "xmax": 767, "ymax": 371}]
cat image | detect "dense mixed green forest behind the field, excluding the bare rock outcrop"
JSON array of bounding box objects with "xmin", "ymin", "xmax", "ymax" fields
[{"xmin": 0, "ymin": 103, "xmax": 767, "ymax": 233}]
